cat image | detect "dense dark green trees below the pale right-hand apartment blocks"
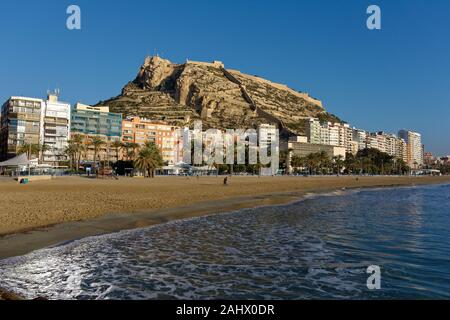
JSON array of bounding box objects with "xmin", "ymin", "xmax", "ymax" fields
[{"xmin": 291, "ymin": 148, "xmax": 410, "ymax": 175}]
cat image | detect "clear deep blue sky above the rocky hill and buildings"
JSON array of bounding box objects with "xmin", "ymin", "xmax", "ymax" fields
[{"xmin": 0, "ymin": 0, "xmax": 450, "ymax": 155}]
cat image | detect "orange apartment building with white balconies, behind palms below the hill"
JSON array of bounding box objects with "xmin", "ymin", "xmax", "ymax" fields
[{"xmin": 122, "ymin": 117, "xmax": 183, "ymax": 166}]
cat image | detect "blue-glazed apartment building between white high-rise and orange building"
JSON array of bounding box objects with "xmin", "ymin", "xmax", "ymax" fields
[{"xmin": 71, "ymin": 103, "xmax": 122, "ymax": 162}]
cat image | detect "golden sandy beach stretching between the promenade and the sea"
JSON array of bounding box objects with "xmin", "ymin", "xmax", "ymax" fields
[{"xmin": 0, "ymin": 176, "xmax": 450, "ymax": 259}]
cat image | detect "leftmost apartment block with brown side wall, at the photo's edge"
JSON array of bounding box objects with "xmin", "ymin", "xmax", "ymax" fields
[{"xmin": 0, "ymin": 97, "xmax": 44, "ymax": 160}]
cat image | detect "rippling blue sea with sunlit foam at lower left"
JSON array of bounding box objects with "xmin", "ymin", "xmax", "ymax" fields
[{"xmin": 0, "ymin": 185, "xmax": 450, "ymax": 300}]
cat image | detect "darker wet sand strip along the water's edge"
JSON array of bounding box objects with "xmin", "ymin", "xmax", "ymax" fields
[{"xmin": 0, "ymin": 177, "xmax": 450, "ymax": 260}]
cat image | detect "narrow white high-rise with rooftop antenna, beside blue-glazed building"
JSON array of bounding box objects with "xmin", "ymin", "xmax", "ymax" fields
[{"xmin": 40, "ymin": 93, "xmax": 71, "ymax": 166}]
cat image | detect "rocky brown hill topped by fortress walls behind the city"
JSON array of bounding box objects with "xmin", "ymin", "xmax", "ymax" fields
[{"xmin": 98, "ymin": 57, "xmax": 334, "ymax": 134}]
